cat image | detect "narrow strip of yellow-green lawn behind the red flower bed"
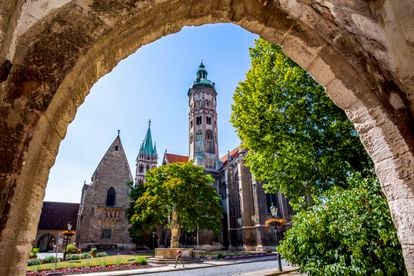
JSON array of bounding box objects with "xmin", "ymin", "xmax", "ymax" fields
[{"xmin": 27, "ymin": 255, "xmax": 150, "ymax": 271}]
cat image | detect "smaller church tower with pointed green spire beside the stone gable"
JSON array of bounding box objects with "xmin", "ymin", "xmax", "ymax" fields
[{"xmin": 135, "ymin": 120, "xmax": 158, "ymax": 185}]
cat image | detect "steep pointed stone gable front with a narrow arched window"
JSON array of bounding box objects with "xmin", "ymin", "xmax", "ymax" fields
[{"xmin": 77, "ymin": 136, "xmax": 132, "ymax": 248}]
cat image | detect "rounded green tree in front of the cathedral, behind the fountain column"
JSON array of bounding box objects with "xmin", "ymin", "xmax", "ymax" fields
[{"xmin": 130, "ymin": 163, "xmax": 222, "ymax": 247}]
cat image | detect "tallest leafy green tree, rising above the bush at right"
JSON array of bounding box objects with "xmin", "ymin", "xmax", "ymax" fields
[{"xmin": 231, "ymin": 39, "xmax": 373, "ymax": 207}]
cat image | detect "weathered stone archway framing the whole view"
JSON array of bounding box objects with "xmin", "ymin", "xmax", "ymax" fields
[{"xmin": 0, "ymin": 0, "xmax": 414, "ymax": 275}]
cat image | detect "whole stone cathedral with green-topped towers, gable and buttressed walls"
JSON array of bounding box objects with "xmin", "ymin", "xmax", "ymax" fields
[{"xmin": 34, "ymin": 63, "xmax": 292, "ymax": 251}]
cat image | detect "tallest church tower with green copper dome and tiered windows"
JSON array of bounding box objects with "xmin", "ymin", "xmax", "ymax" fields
[{"xmin": 188, "ymin": 62, "xmax": 219, "ymax": 171}]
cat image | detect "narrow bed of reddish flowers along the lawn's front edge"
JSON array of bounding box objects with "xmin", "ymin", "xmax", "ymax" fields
[{"xmin": 26, "ymin": 264, "xmax": 149, "ymax": 276}]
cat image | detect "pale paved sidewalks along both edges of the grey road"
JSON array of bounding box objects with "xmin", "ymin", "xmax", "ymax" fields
[{"xmin": 71, "ymin": 256, "xmax": 300, "ymax": 276}]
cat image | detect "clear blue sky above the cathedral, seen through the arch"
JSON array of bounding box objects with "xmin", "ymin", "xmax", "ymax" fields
[{"xmin": 45, "ymin": 24, "xmax": 257, "ymax": 202}]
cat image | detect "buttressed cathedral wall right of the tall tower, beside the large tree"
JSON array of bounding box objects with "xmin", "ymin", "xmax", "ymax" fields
[{"xmin": 219, "ymin": 150, "xmax": 292, "ymax": 251}]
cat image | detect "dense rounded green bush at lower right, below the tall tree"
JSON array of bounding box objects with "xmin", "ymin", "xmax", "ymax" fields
[{"xmin": 278, "ymin": 174, "xmax": 406, "ymax": 275}]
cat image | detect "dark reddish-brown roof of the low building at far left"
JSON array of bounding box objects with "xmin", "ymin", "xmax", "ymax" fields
[{"xmin": 37, "ymin": 201, "xmax": 79, "ymax": 230}]
